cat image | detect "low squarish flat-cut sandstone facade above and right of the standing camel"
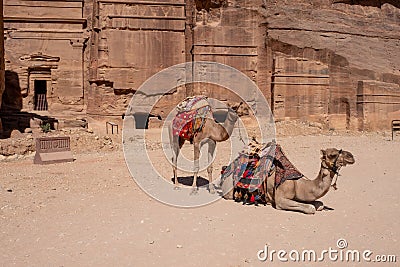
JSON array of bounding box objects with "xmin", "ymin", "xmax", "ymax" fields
[{"xmin": 271, "ymin": 53, "xmax": 330, "ymax": 123}]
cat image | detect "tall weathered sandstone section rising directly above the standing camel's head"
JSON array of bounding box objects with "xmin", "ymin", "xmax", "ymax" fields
[{"xmin": 189, "ymin": 0, "xmax": 270, "ymax": 108}]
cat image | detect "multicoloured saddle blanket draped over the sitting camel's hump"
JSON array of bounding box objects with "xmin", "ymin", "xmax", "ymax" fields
[{"xmin": 221, "ymin": 144, "xmax": 303, "ymax": 192}]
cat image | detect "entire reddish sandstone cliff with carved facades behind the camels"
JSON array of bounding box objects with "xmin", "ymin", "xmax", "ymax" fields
[{"xmin": 4, "ymin": 0, "xmax": 400, "ymax": 130}]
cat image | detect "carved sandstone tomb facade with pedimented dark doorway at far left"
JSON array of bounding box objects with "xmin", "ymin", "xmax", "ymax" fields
[{"xmin": 4, "ymin": 0, "xmax": 86, "ymax": 116}]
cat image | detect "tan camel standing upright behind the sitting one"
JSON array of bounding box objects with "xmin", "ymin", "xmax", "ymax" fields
[{"xmin": 169, "ymin": 102, "xmax": 240, "ymax": 194}]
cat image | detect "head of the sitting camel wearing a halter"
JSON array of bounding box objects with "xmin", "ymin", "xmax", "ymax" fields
[{"xmin": 321, "ymin": 148, "xmax": 355, "ymax": 172}]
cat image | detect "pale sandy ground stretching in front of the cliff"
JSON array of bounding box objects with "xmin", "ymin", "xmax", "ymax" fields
[{"xmin": 0, "ymin": 131, "xmax": 400, "ymax": 266}]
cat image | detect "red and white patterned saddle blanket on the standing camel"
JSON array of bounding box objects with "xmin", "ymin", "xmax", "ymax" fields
[{"xmin": 172, "ymin": 96, "xmax": 212, "ymax": 142}]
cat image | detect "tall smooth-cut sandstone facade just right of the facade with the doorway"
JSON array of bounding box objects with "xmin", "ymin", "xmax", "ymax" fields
[{"xmin": 87, "ymin": 0, "xmax": 186, "ymax": 117}]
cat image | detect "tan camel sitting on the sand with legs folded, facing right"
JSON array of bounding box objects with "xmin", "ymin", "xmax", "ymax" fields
[{"xmin": 222, "ymin": 148, "xmax": 355, "ymax": 214}]
